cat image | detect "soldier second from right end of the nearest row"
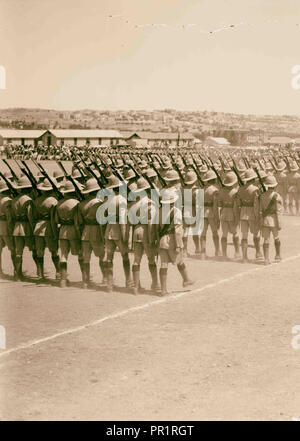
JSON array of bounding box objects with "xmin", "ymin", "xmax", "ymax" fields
[{"xmin": 129, "ymin": 177, "xmax": 159, "ymax": 295}]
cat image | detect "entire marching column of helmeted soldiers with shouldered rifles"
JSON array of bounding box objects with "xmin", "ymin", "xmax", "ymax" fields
[{"xmin": 0, "ymin": 145, "xmax": 300, "ymax": 296}]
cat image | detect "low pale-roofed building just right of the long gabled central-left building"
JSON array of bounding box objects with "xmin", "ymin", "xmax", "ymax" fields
[{"xmin": 123, "ymin": 131, "xmax": 195, "ymax": 147}]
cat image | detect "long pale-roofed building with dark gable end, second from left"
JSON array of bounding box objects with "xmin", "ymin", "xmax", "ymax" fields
[{"xmin": 50, "ymin": 129, "xmax": 124, "ymax": 147}]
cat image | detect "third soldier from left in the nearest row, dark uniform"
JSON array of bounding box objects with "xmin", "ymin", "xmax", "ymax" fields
[{"xmin": 33, "ymin": 178, "xmax": 59, "ymax": 280}]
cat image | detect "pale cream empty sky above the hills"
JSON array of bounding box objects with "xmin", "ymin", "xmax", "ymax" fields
[{"xmin": 0, "ymin": 0, "xmax": 300, "ymax": 115}]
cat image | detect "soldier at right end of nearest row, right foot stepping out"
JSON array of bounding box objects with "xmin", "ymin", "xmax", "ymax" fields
[{"xmin": 158, "ymin": 188, "xmax": 194, "ymax": 296}]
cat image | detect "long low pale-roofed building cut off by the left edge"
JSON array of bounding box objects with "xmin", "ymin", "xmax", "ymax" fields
[{"xmin": 0, "ymin": 129, "xmax": 52, "ymax": 146}]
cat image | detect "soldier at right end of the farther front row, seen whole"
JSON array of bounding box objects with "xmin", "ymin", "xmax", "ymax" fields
[{"xmin": 259, "ymin": 175, "xmax": 283, "ymax": 265}]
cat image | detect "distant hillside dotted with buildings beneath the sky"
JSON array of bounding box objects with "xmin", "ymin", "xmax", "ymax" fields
[{"xmin": 0, "ymin": 108, "xmax": 300, "ymax": 137}]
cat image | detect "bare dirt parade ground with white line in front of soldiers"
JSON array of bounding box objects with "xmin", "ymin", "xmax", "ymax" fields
[{"xmin": 0, "ymin": 216, "xmax": 300, "ymax": 420}]
